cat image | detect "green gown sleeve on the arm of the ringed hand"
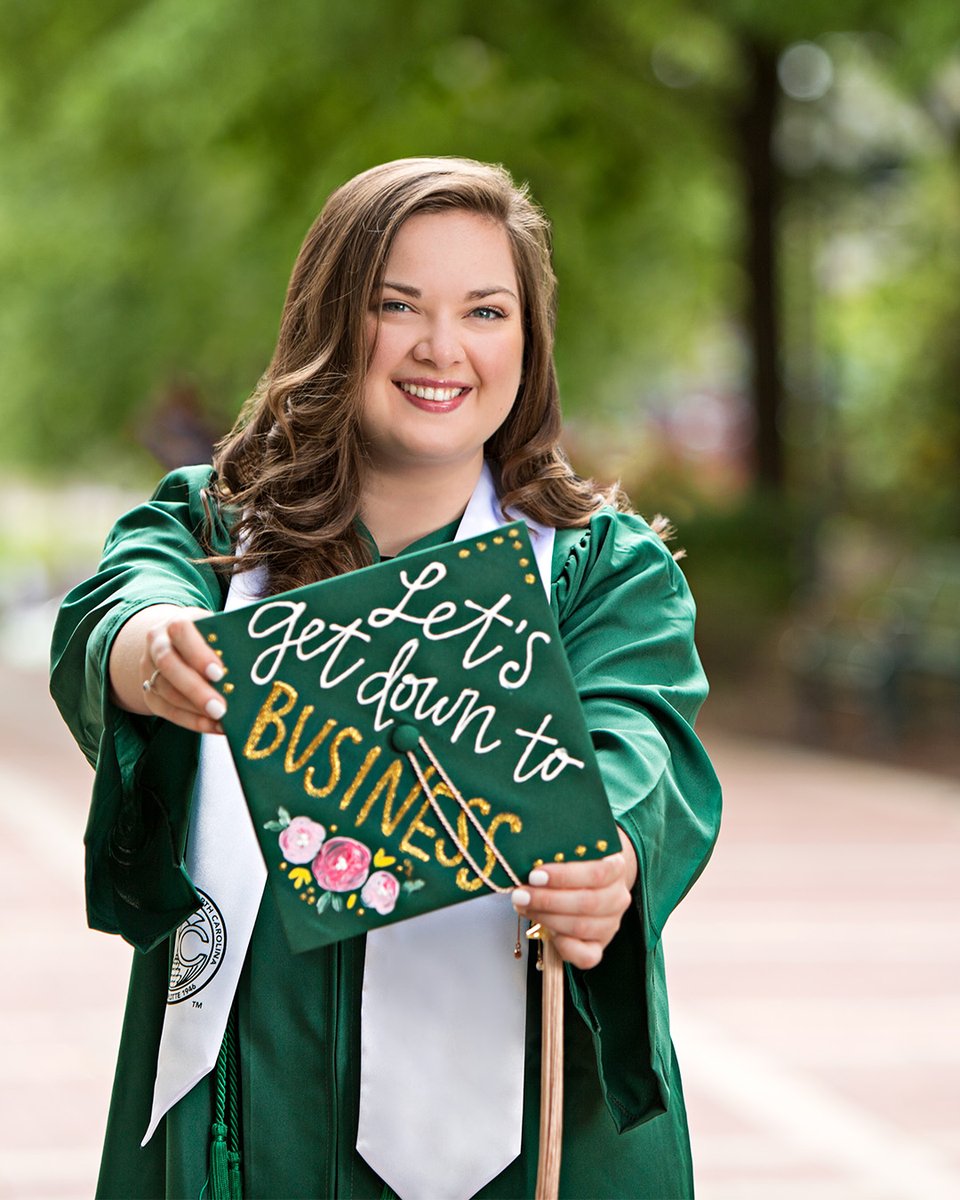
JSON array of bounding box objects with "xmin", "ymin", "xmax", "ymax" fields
[{"xmin": 50, "ymin": 467, "xmax": 229, "ymax": 950}]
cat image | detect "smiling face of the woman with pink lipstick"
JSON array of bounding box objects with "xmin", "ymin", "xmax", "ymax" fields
[{"xmin": 361, "ymin": 210, "xmax": 523, "ymax": 474}]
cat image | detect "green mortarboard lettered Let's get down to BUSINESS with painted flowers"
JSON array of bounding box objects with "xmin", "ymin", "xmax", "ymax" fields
[{"xmin": 198, "ymin": 523, "xmax": 619, "ymax": 952}]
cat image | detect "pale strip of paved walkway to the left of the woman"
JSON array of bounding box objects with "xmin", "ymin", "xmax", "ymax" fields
[{"xmin": 0, "ymin": 668, "xmax": 131, "ymax": 1200}]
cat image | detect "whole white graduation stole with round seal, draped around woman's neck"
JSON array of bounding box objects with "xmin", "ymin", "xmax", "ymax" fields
[{"xmin": 142, "ymin": 463, "xmax": 554, "ymax": 1200}]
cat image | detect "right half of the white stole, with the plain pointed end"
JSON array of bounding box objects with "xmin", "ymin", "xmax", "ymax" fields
[{"xmin": 356, "ymin": 464, "xmax": 554, "ymax": 1200}]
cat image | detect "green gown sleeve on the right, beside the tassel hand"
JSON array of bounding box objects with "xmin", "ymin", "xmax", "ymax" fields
[{"xmin": 554, "ymin": 510, "xmax": 720, "ymax": 1132}]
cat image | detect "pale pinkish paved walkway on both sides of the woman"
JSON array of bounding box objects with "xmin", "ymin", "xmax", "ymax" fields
[{"xmin": 0, "ymin": 670, "xmax": 960, "ymax": 1200}]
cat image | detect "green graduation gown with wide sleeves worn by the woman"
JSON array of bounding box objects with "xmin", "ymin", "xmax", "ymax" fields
[{"xmin": 52, "ymin": 467, "xmax": 720, "ymax": 1200}]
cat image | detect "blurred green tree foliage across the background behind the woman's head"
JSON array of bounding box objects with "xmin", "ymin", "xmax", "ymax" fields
[{"xmin": 0, "ymin": 0, "xmax": 960, "ymax": 537}]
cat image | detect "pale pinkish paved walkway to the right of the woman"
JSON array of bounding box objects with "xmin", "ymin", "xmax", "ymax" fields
[{"xmin": 666, "ymin": 737, "xmax": 960, "ymax": 1200}]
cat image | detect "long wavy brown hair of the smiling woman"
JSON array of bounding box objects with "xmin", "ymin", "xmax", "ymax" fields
[{"xmin": 211, "ymin": 158, "xmax": 620, "ymax": 592}]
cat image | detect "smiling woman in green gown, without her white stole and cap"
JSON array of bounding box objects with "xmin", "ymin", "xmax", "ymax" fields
[{"xmin": 52, "ymin": 158, "xmax": 719, "ymax": 1198}]
